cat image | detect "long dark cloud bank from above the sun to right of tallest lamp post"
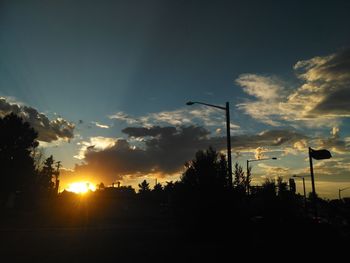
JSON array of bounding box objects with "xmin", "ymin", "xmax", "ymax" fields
[{"xmin": 72, "ymin": 126, "xmax": 305, "ymax": 184}]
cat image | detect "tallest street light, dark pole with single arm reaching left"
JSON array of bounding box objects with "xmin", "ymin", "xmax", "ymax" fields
[{"xmin": 186, "ymin": 101, "xmax": 232, "ymax": 188}]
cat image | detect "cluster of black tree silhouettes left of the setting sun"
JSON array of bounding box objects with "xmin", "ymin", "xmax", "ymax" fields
[{"xmin": 0, "ymin": 113, "xmax": 59, "ymax": 206}]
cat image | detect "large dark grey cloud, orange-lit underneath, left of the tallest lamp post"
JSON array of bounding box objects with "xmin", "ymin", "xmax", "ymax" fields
[{"xmin": 72, "ymin": 126, "xmax": 208, "ymax": 184}]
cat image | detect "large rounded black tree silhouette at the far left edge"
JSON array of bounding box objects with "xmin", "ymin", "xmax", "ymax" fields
[{"xmin": 0, "ymin": 113, "xmax": 38, "ymax": 202}]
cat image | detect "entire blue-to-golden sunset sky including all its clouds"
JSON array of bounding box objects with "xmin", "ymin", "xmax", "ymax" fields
[{"xmin": 0, "ymin": 0, "xmax": 350, "ymax": 198}]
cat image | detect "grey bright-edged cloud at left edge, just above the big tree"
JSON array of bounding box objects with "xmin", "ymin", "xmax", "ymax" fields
[{"xmin": 0, "ymin": 97, "xmax": 75, "ymax": 142}]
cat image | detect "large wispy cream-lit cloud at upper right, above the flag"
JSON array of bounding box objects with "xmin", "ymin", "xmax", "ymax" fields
[{"xmin": 236, "ymin": 49, "xmax": 350, "ymax": 127}]
